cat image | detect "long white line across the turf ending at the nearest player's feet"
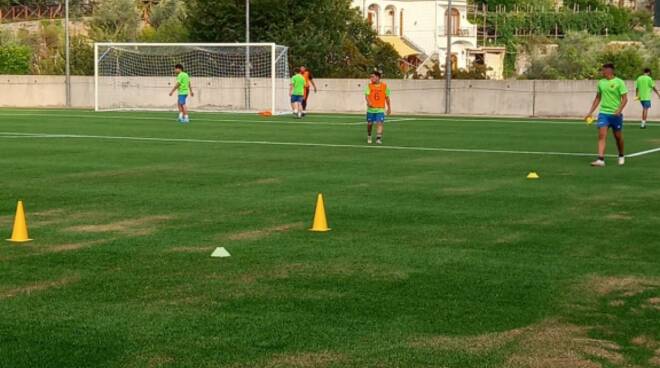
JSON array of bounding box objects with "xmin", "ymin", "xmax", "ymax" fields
[{"xmin": 0, "ymin": 132, "xmax": 613, "ymax": 157}]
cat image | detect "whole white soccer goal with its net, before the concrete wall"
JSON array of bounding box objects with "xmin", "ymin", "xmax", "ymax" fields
[{"xmin": 94, "ymin": 43, "xmax": 290, "ymax": 114}]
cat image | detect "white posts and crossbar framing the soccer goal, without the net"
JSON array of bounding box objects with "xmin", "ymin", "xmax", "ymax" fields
[{"xmin": 94, "ymin": 42, "xmax": 290, "ymax": 115}]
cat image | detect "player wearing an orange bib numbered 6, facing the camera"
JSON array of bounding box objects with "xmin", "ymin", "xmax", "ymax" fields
[{"xmin": 364, "ymin": 71, "xmax": 392, "ymax": 144}]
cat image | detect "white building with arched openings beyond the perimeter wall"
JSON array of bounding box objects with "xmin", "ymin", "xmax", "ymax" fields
[{"xmin": 352, "ymin": 0, "xmax": 477, "ymax": 68}]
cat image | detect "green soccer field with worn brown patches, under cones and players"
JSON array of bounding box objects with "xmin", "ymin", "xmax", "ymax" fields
[{"xmin": 0, "ymin": 110, "xmax": 660, "ymax": 368}]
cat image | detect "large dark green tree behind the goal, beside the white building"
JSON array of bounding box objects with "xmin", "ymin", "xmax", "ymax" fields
[{"xmin": 186, "ymin": 0, "xmax": 401, "ymax": 78}]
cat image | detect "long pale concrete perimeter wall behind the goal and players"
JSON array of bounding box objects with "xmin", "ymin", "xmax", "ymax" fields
[{"xmin": 0, "ymin": 76, "xmax": 660, "ymax": 120}]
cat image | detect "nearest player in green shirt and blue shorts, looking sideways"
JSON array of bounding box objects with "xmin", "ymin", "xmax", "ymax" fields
[{"xmin": 585, "ymin": 64, "xmax": 628, "ymax": 167}]
